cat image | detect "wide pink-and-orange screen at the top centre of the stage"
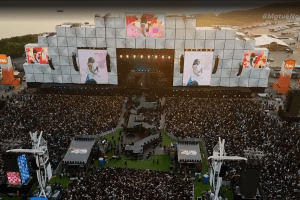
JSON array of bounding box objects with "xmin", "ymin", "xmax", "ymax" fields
[{"xmin": 126, "ymin": 14, "xmax": 165, "ymax": 38}]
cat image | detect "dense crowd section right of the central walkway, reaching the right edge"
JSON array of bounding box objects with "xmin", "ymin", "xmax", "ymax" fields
[{"xmin": 166, "ymin": 97, "xmax": 300, "ymax": 200}]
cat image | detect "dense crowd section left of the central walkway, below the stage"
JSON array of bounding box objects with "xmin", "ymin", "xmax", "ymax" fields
[{"xmin": 0, "ymin": 90, "xmax": 124, "ymax": 184}]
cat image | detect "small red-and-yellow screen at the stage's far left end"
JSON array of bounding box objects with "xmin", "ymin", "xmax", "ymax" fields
[{"xmin": 26, "ymin": 47, "xmax": 49, "ymax": 64}]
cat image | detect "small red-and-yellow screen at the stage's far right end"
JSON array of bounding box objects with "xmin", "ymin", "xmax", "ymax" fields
[{"xmin": 243, "ymin": 51, "xmax": 268, "ymax": 68}]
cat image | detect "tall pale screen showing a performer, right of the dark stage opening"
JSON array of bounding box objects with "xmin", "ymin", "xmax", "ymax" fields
[{"xmin": 183, "ymin": 51, "xmax": 214, "ymax": 86}]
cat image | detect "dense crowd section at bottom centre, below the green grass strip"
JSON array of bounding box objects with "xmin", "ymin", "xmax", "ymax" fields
[{"xmin": 62, "ymin": 168, "xmax": 193, "ymax": 200}]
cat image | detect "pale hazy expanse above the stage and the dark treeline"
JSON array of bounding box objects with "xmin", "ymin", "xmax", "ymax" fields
[{"xmin": 0, "ymin": 0, "xmax": 288, "ymax": 39}]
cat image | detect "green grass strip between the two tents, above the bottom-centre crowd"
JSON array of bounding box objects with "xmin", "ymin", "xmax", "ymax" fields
[{"xmin": 94, "ymin": 152, "xmax": 171, "ymax": 171}]
